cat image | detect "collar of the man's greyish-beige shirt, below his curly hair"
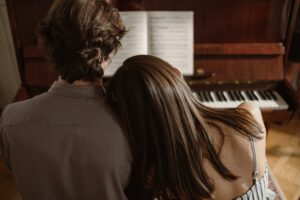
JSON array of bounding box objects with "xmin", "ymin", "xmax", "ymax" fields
[{"xmin": 48, "ymin": 81, "xmax": 104, "ymax": 98}]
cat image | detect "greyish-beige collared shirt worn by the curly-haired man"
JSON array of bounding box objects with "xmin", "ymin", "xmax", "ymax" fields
[{"xmin": 0, "ymin": 82, "xmax": 132, "ymax": 200}]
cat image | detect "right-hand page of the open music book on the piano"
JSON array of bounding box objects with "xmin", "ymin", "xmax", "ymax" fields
[{"xmin": 148, "ymin": 11, "xmax": 194, "ymax": 75}]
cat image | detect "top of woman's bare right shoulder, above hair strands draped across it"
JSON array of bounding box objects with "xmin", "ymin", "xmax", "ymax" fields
[{"xmin": 238, "ymin": 102, "xmax": 266, "ymax": 134}]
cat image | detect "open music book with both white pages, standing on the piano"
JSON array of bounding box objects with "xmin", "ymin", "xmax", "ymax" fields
[{"xmin": 104, "ymin": 11, "xmax": 194, "ymax": 76}]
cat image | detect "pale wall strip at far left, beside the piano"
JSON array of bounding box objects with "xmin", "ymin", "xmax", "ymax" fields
[{"xmin": 0, "ymin": 0, "xmax": 21, "ymax": 109}]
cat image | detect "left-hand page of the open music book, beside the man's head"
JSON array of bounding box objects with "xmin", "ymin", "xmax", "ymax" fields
[{"xmin": 104, "ymin": 11, "xmax": 148, "ymax": 76}]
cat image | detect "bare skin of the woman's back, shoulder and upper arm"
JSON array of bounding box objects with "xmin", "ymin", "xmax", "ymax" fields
[{"xmin": 206, "ymin": 102, "xmax": 266, "ymax": 198}]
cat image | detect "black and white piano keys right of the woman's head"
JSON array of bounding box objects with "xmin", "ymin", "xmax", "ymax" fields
[{"xmin": 194, "ymin": 90, "xmax": 289, "ymax": 110}]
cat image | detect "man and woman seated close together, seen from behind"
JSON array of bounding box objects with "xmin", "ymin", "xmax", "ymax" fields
[{"xmin": 0, "ymin": 0, "xmax": 268, "ymax": 200}]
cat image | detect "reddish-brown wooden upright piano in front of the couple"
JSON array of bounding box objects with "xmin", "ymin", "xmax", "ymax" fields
[{"xmin": 7, "ymin": 0, "xmax": 299, "ymax": 122}]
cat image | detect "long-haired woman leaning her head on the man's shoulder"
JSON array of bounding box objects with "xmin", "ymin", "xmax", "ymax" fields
[{"xmin": 107, "ymin": 55, "xmax": 274, "ymax": 200}]
